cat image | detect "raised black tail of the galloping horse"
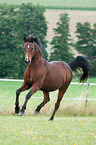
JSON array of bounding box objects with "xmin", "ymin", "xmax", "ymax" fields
[{"xmin": 68, "ymin": 56, "xmax": 90, "ymax": 82}]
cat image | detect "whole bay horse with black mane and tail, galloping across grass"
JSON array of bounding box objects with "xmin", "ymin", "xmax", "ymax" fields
[{"xmin": 15, "ymin": 36, "xmax": 89, "ymax": 120}]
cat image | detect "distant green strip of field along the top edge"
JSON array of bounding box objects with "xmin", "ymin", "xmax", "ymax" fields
[{"xmin": 0, "ymin": 0, "xmax": 96, "ymax": 9}]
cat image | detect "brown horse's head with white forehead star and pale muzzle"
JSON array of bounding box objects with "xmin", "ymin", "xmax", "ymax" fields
[{"xmin": 24, "ymin": 37, "xmax": 35, "ymax": 65}]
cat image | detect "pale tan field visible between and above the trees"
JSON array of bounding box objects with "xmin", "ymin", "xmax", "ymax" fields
[{"xmin": 44, "ymin": 9, "xmax": 96, "ymax": 56}]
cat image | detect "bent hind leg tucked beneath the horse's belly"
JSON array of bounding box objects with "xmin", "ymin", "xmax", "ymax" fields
[{"xmin": 33, "ymin": 91, "xmax": 50, "ymax": 115}]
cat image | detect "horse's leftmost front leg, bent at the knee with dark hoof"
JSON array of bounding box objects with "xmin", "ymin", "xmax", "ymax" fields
[{"xmin": 15, "ymin": 82, "xmax": 30, "ymax": 113}]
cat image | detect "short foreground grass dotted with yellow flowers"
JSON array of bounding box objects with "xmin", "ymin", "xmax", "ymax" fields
[{"xmin": 0, "ymin": 116, "xmax": 96, "ymax": 145}]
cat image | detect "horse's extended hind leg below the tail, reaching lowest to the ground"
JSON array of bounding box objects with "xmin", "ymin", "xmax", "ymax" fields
[{"xmin": 49, "ymin": 82, "xmax": 70, "ymax": 120}]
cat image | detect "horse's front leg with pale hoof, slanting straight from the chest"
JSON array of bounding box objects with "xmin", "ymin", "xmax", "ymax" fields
[{"xmin": 18, "ymin": 83, "xmax": 40, "ymax": 116}]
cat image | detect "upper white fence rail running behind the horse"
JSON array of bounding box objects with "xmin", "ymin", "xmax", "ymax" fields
[{"xmin": 0, "ymin": 79, "xmax": 96, "ymax": 86}]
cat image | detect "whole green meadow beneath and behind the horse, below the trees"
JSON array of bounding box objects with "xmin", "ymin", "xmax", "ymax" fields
[{"xmin": 0, "ymin": 78, "xmax": 96, "ymax": 145}]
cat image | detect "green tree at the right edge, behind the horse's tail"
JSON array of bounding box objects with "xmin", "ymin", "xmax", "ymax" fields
[{"xmin": 75, "ymin": 22, "xmax": 96, "ymax": 76}]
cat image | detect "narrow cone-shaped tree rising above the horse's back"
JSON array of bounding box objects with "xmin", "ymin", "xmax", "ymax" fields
[{"xmin": 50, "ymin": 13, "xmax": 73, "ymax": 62}]
